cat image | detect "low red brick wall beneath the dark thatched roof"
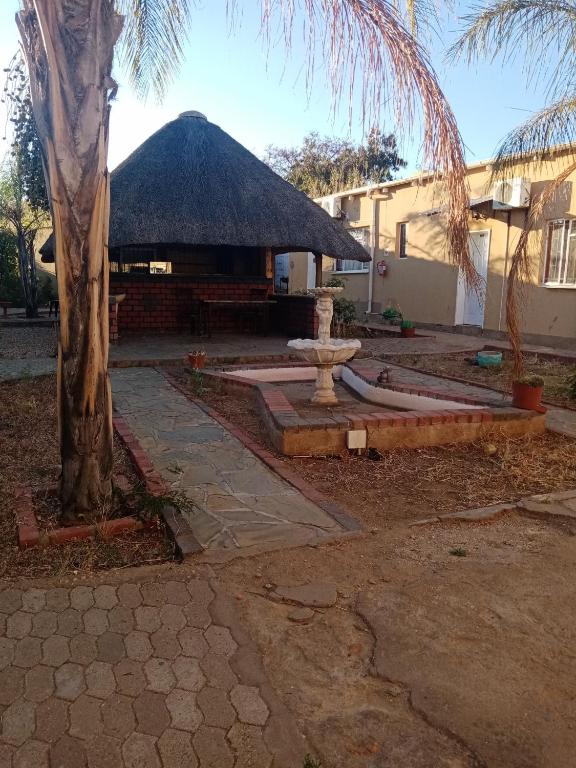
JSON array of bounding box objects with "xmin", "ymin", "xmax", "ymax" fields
[{"xmin": 110, "ymin": 273, "xmax": 272, "ymax": 336}]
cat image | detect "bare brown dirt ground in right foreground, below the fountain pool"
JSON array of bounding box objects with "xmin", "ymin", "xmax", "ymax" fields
[{"xmin": 173, "ymin": 368, "xmax": 576, "ymax": 768}]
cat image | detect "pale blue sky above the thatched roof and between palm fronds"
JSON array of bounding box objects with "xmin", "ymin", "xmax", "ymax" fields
[{"xmin": 0, "ymin": 0, "xmax": 545, "ymax": 173}]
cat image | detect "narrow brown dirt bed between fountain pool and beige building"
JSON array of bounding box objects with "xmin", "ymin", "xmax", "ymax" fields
[{"xmin": 385, "ymin": 352, "xmax": 576, "ymax": 408}]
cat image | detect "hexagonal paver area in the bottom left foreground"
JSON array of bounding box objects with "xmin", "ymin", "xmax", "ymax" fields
[{"xmin": 0, "ymin": 566, "xmax": 304, "ymax": 768}]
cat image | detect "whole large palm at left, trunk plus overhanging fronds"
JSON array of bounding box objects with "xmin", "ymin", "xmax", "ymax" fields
[{"xmin": 17, "ymin": 0, "xmax": 475, "ymax": 518}]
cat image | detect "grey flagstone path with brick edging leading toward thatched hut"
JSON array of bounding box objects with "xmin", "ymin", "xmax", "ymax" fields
[{"xmin": 111, "ymin": 368, "xmax": 344, "ymax": 559}]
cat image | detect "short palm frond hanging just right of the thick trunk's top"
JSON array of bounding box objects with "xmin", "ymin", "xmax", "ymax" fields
[{"xmin": 117, "ymin": 0, "xmax": 193, "ymax": 100}]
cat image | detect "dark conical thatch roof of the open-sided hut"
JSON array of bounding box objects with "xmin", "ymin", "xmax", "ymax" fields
[{"xmin": 41, "ymin": 112, "xmax": 370, "ymax": 261}]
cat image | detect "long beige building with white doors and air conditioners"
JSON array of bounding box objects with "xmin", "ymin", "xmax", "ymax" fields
[{"xmin": 284, "ymin": 147, "xmax": 576, "ymax": 347}]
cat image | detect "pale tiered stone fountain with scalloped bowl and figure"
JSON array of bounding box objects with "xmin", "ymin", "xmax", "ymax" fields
[{"xmin": 288, "ymin": 288, "xmax": 362, "ymax": 405}]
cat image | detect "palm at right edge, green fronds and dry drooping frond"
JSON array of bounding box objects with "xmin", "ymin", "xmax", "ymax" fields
[{"xmin": 450, "ymin": 0, "xmax": 576, "ymax": 375}]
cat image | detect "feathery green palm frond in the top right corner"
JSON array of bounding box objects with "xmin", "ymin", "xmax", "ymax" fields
[{"xmin": 448, "ymin": 0, "xmax": 576, "ymax": 98}]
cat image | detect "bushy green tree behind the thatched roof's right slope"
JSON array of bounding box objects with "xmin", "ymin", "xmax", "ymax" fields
[{"xmin": 264, "ymin": 128, "xmax": 406, "ymax": 197}]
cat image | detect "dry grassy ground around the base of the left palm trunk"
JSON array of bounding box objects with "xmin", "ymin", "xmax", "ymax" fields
[{"xmin": 0, "ymin": 376, "xmax": 173, "ymax": 577}]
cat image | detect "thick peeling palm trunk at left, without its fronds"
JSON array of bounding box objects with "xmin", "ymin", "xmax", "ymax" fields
[{"xmin": 17, "ymin": 0, "xmax": 122, "ymax": 521}]
